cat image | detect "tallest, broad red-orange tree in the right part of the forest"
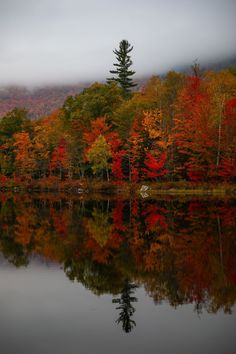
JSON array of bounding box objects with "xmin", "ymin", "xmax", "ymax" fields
[{"xmin": 174, "ymin": 77, "xmax": 215, "ymax": 181}]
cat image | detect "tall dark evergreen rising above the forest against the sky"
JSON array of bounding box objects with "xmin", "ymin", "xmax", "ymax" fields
[{"xmin": 107, "ymin": 39, "xmax": 136, "ymax": 96}]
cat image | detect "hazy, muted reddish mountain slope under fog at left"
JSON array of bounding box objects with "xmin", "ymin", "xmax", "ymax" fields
[{"xmin": 0, "ymin": 84, "xmax": 89, "ymax": 119}]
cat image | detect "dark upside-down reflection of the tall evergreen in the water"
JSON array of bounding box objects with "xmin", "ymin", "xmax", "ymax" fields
[{"xmin": 112, "ymin": 279, "xmax": 138, "ymax": 333}]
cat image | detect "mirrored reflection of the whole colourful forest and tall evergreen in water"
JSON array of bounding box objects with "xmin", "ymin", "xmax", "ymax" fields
[{"xmin": 0, "ymin": 194, "xmax": 236, "ymax": 333}]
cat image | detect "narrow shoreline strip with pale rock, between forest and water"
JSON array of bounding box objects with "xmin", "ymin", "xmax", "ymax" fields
[{"xmin": 0, "ymin": 181, "xmax": 236, "ymax": 198}]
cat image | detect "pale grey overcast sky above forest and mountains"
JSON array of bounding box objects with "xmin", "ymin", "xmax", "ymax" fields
[{"xmin": 0, "ymin": 0, "xmax": 236, "ymax": 85}]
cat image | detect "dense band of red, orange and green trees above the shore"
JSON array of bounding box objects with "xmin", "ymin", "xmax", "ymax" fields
[{"xmin": 0, "ymin": 65, "xmax": 236, "ymax": 186}]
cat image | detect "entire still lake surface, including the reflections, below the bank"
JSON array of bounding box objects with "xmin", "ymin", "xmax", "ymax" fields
[{"xmin": 0, "ymin": 194, "xmax": 236, "ymax": 354}]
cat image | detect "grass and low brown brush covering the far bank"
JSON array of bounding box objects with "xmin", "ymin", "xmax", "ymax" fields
[{"xmin": 0, "ymin": 176, "xmax": 236, "ymax": 196}]
